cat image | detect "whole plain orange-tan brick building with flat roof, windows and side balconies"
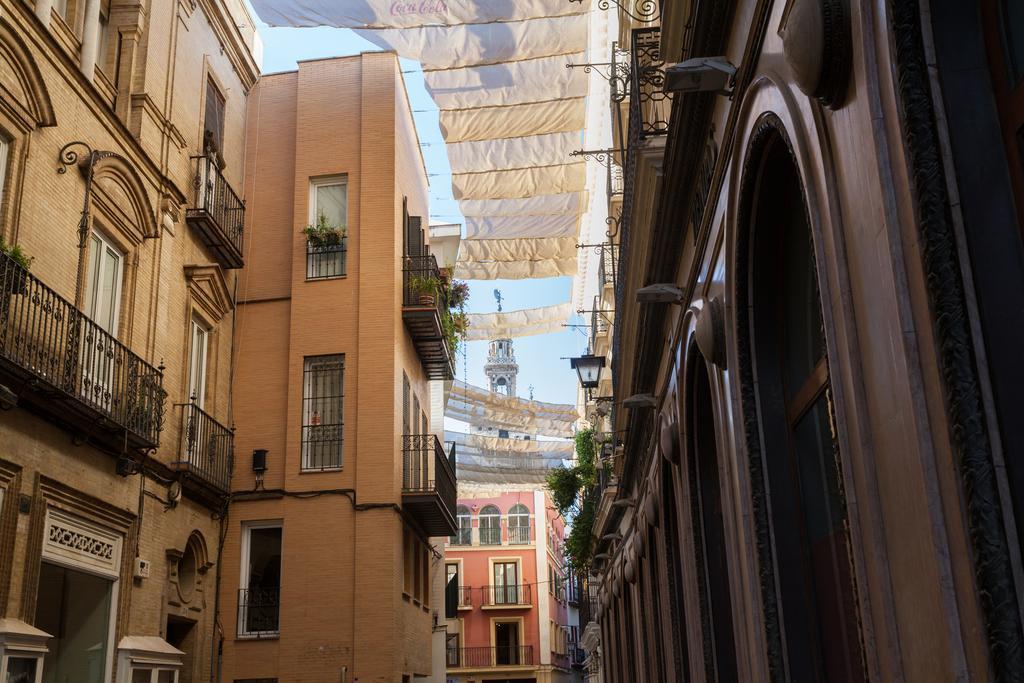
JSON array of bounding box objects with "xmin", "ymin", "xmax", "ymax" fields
[{"xmin": 220, "ymin": 52, "xmax": 456, "ymax": 683}]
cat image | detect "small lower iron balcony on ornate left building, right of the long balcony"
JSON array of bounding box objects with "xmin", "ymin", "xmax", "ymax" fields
[{"xmin": 172, "ymin": 401, "xmax": 234, "ymax": 497}]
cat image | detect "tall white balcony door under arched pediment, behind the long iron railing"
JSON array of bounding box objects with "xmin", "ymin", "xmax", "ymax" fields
[{"xmin": 80, "ymin": 230, "xmax": 124, "ymax": 411}]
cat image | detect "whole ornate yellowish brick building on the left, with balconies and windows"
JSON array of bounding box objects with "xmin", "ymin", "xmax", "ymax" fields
[{"xmin": 0, "ymin": 0, "xmax": 259, "ymax": 682}]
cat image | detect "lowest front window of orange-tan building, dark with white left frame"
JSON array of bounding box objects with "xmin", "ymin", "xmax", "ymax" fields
[{"xmin": 239, "ymin": 523, "xmax": 284, "ymax": 638}]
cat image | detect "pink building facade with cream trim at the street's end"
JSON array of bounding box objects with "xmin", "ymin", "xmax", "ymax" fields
[{"xmin": 444, "ymin": 486, "xmax": 574, "ymax": 683}]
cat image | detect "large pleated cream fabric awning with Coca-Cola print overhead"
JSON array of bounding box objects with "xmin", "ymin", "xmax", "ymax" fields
[{"xmin": 253, "ymin": 0, "xmax": 593, "ymax": 280}]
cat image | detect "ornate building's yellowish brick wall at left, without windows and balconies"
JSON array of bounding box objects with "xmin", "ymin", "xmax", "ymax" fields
[{"xmin": 0, "ymin": 0, "xmax": 256, "ymax": 681}]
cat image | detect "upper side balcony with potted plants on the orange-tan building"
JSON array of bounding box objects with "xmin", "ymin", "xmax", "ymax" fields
[{"xmin": 401, "ymin": 254, "xmax": 455, "ymax": 380}]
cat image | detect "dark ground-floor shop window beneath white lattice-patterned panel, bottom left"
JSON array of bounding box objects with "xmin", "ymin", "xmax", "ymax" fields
[{"xmin": 35, "ymin": 561, "xmax": 114, "ymax": 683}]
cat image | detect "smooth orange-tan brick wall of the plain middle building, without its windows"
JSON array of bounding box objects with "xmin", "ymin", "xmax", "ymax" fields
[{"xmin": 221, "ymin": 53, "xmax": 441, "ymax": 683}]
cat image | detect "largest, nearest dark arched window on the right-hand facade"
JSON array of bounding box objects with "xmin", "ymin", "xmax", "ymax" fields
[{"xmin": 744, "ymin": 124, "xmax": 864, "ymax": 682}]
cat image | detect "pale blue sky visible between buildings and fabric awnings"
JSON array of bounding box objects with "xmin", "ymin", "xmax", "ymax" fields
[{"xmin": 254, "ymin": 21, "xmax": 587, "ymax": 403}]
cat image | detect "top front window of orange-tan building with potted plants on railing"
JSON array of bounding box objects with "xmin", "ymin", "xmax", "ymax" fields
[{"xmin": 306, "ymin": 176, "xmax": 348, "ymax": 280}]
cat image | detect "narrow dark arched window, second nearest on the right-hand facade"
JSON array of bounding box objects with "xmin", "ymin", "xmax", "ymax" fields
[{"xmin": 686, "ymin": 349, "xmax": 739, "ymax": 681}]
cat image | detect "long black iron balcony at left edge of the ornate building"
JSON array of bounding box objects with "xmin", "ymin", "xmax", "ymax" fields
[{"xmin": 0, "ymin": 253, "xmax": 167, "ymax": 453}]
